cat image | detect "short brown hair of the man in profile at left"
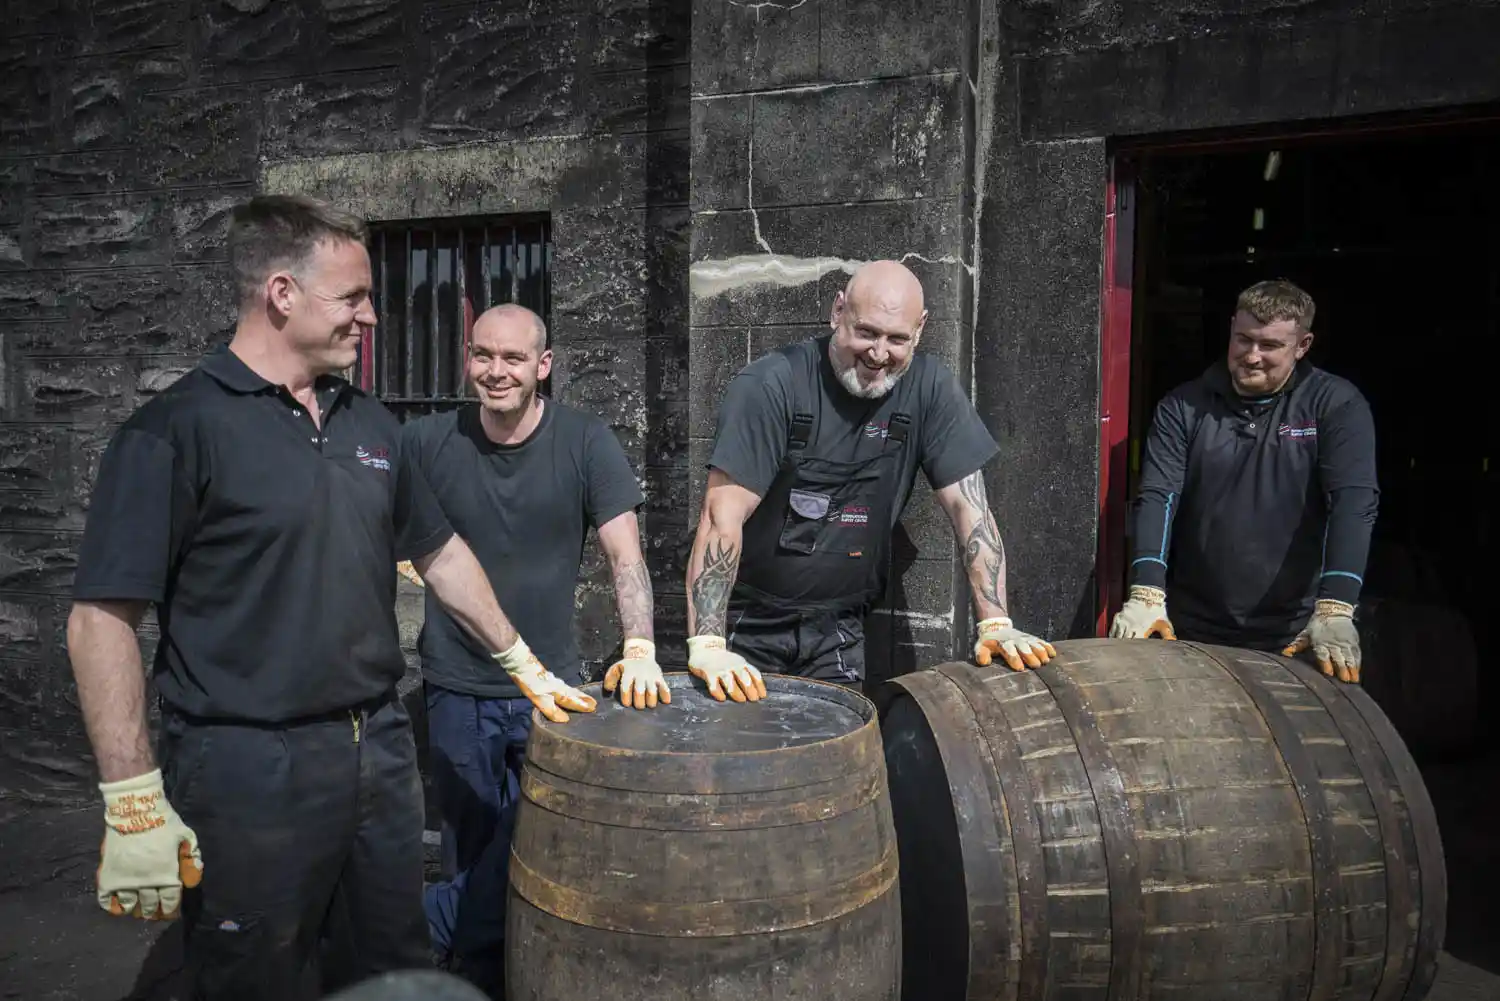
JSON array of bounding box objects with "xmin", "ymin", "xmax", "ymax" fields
[{"xmin": 230, "ymin": 195, "xmax": 369, "ymax": 303}]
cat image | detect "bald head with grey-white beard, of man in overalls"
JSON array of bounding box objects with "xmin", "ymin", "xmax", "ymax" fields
[{"xmin": 828, "ymin": 261, "xmax": 927, "ymax": 399}]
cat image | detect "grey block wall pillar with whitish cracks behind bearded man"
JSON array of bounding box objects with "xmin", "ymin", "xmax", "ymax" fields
[{"xmin": 690, "ymin": 0, "xmax": 984, "ymax": 675}]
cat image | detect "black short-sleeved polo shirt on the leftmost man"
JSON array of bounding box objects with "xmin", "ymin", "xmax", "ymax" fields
[{"xmin": 74, "ymin": 347, "xmax": 453, "ymax": 723}]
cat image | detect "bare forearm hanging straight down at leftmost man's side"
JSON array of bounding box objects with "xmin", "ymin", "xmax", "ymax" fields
[{"xmin": 68, "ymin": 603, "xmax": 156, "ymax": 782}]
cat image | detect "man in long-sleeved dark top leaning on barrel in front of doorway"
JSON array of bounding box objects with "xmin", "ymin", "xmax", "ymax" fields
[{"xmin": 1110, "ymin": 281, "xmax": 1379, "ymax": 681}]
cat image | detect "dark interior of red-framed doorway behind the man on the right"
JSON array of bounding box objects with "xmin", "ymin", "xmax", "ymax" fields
[{"xmin": 1130, "ymin": 125, "xmax": 1500, "ymax": 756}]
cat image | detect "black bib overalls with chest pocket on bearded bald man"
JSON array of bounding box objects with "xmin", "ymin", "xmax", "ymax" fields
[{"xmin": 728, "ymin": 353, "xmax": 912, "ymax": 684}]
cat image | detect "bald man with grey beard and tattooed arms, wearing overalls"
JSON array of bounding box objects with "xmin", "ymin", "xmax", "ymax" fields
[{"xmin": 687, "ymin": 261, "xmax": 1056, "ymax": 701}]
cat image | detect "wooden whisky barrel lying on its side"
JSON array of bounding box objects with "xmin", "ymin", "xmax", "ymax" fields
[{"xmin": 878, "ymin": 639, "xmax": 1448, "ymax": 1001}]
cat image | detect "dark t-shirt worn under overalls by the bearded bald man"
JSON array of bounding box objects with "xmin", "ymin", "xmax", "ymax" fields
[{"xmin": 708, "ymin": 336, "xmax": 999, "ymax": 528}]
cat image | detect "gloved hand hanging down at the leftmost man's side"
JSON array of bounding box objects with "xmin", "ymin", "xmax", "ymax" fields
[{"xmin": 96, "ymin": 768, "xmax": 203, "ymax": 921}]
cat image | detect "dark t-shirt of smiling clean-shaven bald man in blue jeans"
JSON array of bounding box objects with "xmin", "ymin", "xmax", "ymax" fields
[{"xmin": 405, "ymin": 399, "xmax": 645, "ymax": 698}]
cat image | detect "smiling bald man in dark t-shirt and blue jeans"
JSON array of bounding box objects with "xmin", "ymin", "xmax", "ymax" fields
[{"xmin": 405, "ymin": 305, "xmax": 671, "ymax": 996}]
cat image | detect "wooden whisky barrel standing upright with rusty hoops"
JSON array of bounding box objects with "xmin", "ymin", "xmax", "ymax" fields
[{"xmin": 506, "ymin": 674, "xmax": 902, "ymax": 1001}]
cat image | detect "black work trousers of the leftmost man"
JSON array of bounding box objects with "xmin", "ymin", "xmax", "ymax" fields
[{"xmin": 161, "ymin": 695, "xmax": 431, "ymax": 1001}]
